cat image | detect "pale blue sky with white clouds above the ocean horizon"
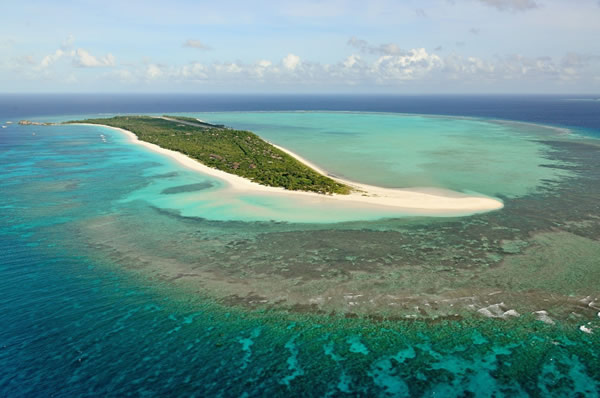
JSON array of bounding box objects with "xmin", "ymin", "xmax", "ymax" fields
[{"xmin": 0, "ymin": 0, "xmax": 600, "ymax": 94}]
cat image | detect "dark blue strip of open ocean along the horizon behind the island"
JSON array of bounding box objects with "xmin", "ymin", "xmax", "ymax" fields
[{"xmin": 0, "ymin": 94, "xmax": 600, "ymax": 133}]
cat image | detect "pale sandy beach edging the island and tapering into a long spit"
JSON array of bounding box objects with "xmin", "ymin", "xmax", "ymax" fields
[{"xmin": 81, "ymin": 123, "xmax": 504, "ymax": 216}]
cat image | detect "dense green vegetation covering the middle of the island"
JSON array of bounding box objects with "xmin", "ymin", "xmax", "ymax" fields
[{"xmin": 67, "ymin": 116, "xmax": 350, "ymax": 194}]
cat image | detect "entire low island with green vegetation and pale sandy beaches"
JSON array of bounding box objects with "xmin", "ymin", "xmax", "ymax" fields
[{"xmin": 57, "ymin": 115, "xmax": 504, "ymax": 217}]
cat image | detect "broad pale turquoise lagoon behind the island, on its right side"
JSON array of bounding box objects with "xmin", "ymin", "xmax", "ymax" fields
[{"xmin": 193, "ymin": 112, "xmax": 568, "ymax": 198}]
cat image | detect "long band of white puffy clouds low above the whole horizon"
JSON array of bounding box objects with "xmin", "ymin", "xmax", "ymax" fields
[{"xmin": 7, "ymin": 33, "xmax": 600, "ymax": 91}]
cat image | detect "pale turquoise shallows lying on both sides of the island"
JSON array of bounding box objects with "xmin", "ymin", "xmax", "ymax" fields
[{"xmin": 37, "ymin": 112, "xmax": 570, "ymax": 223}]
